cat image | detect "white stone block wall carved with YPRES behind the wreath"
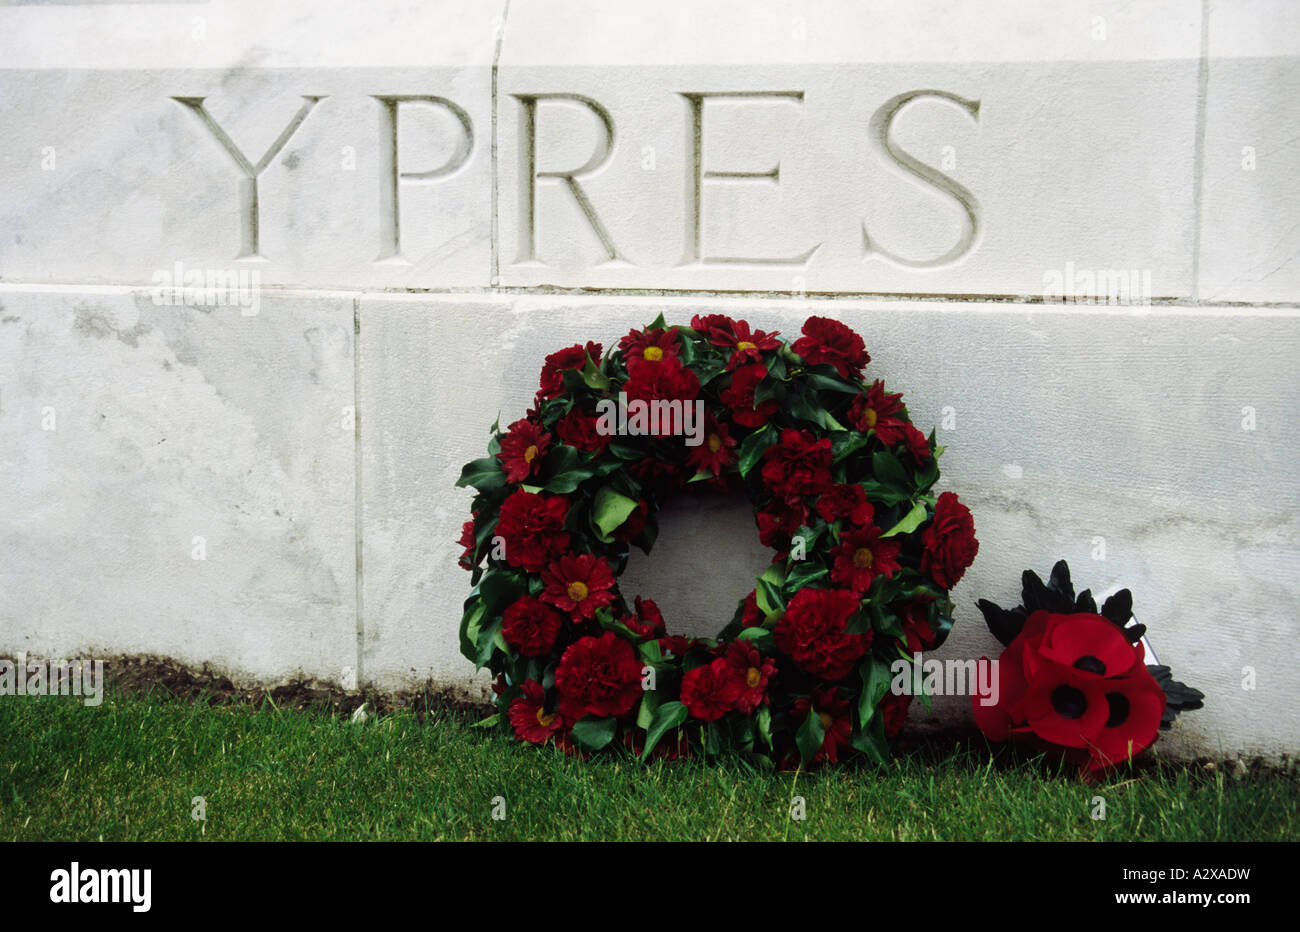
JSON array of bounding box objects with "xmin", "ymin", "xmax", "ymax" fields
[{"xmin": 0, "ymin": 0, "xmax": 1300, "ymax": 755}]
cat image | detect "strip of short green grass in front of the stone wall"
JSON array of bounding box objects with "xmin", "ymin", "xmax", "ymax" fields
[{"xmin": 0, "ymin": 694, "xmax": 1300, "ymax": 841}]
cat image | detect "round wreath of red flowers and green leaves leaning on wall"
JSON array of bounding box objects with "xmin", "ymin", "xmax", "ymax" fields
[{"xmin": 458, "ymin": 315, "xmax": 979, "ymax": 766}]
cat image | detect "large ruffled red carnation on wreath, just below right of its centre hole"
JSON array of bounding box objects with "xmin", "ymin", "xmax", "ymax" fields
[{"xmin": 772, "ymin": 589, "xmax": 872, "ymax": 680}]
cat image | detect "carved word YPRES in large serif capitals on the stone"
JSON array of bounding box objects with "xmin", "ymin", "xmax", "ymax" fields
[{"xmin": 173, "ymin": 90, "xmax": 980, "ymax": 269}]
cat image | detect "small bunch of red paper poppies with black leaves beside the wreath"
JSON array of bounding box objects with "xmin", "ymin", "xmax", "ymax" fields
[{"xmin": 971, "ymin": 560, "xmax": 1205, "ymax": 777}]
